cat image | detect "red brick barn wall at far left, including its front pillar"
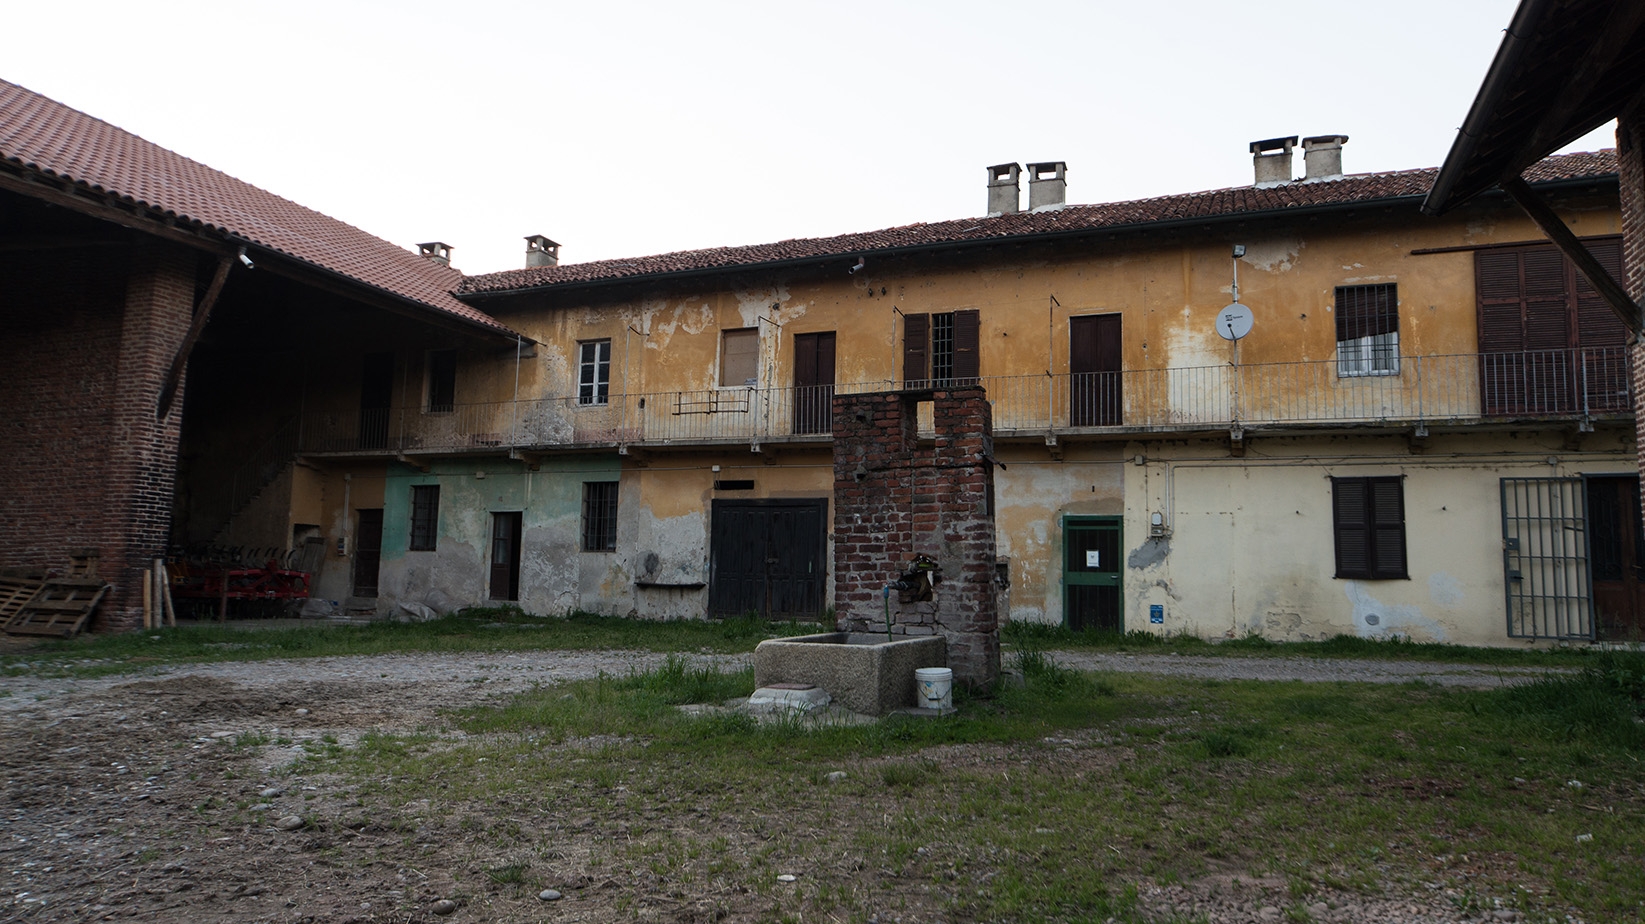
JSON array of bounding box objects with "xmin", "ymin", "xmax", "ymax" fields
[{"xmin": 0, "ymin": 245, "xmax": 194, "ymax": 630}]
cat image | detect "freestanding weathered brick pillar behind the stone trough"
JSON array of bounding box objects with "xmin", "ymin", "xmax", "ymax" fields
[{"xmin": 834, "ymin": 386, "xmax": 1000, "ymax": 687}]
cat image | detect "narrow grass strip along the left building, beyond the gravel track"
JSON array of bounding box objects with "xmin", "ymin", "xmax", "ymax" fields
[{"xmin": 0, "ymin": 607, "xmax": 818, "ymax": 677}]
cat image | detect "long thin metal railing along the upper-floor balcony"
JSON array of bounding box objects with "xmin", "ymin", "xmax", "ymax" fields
[{"xmin": 301, "ymin": 347, "xmax": 1633, "ymax": 454}]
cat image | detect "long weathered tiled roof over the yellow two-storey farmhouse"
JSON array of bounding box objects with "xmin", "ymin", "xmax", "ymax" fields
[{"xmin": 459, "ymin": 150, "xmax": 1617, "ymax": 296}]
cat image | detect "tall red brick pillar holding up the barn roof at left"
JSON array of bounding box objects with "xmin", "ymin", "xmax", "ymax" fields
[{"xmin": 94, "ymin": 242, "xmax": 196, "ymax": 631}]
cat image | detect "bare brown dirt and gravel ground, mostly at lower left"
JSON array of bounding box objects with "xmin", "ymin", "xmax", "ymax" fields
[{"xmin": 0, "ymin": 651, "xmax": 1559, "ymax": 924}]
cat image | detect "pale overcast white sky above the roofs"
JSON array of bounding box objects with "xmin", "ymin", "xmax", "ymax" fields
[{"xmin": 0, "ymin": 0, "xmax": 1614, "ymax": 273}]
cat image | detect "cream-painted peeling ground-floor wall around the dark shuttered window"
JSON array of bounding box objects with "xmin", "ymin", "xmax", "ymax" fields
[{"xmin": 1124, "ymin": 429, "xmax": 1633, "ymax": 644}]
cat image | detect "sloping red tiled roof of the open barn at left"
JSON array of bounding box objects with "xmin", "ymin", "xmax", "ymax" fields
[{"xmin": 0, "ymin": 81, "xmax": 512, "ymax": 334}]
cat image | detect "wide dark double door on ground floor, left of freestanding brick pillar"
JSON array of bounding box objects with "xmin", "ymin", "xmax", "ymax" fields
[{"xmin": 709, "ymin": 498, "xmax": 827, "ymax": 620}]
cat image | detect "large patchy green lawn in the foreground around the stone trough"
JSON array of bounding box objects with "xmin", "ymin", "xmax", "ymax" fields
[{"xmin": 309, "ymin": 648, "xmax": 1645, "ymax": 924}]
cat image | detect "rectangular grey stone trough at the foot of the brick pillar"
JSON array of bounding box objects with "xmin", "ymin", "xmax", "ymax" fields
[{"xmin": 753, "ymin": 631, "xmax": 948, "ymax": 715}]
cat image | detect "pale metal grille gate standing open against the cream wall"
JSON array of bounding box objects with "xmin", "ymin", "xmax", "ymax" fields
[{"xmin": 1502, "ymin": 478, "xmax": 1594, "ymax": 640}]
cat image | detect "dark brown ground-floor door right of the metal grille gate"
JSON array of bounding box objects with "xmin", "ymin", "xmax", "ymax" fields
[{"xmin": 1587, "ymin": 475, "xmax": 1645, "ymax": 641}]
